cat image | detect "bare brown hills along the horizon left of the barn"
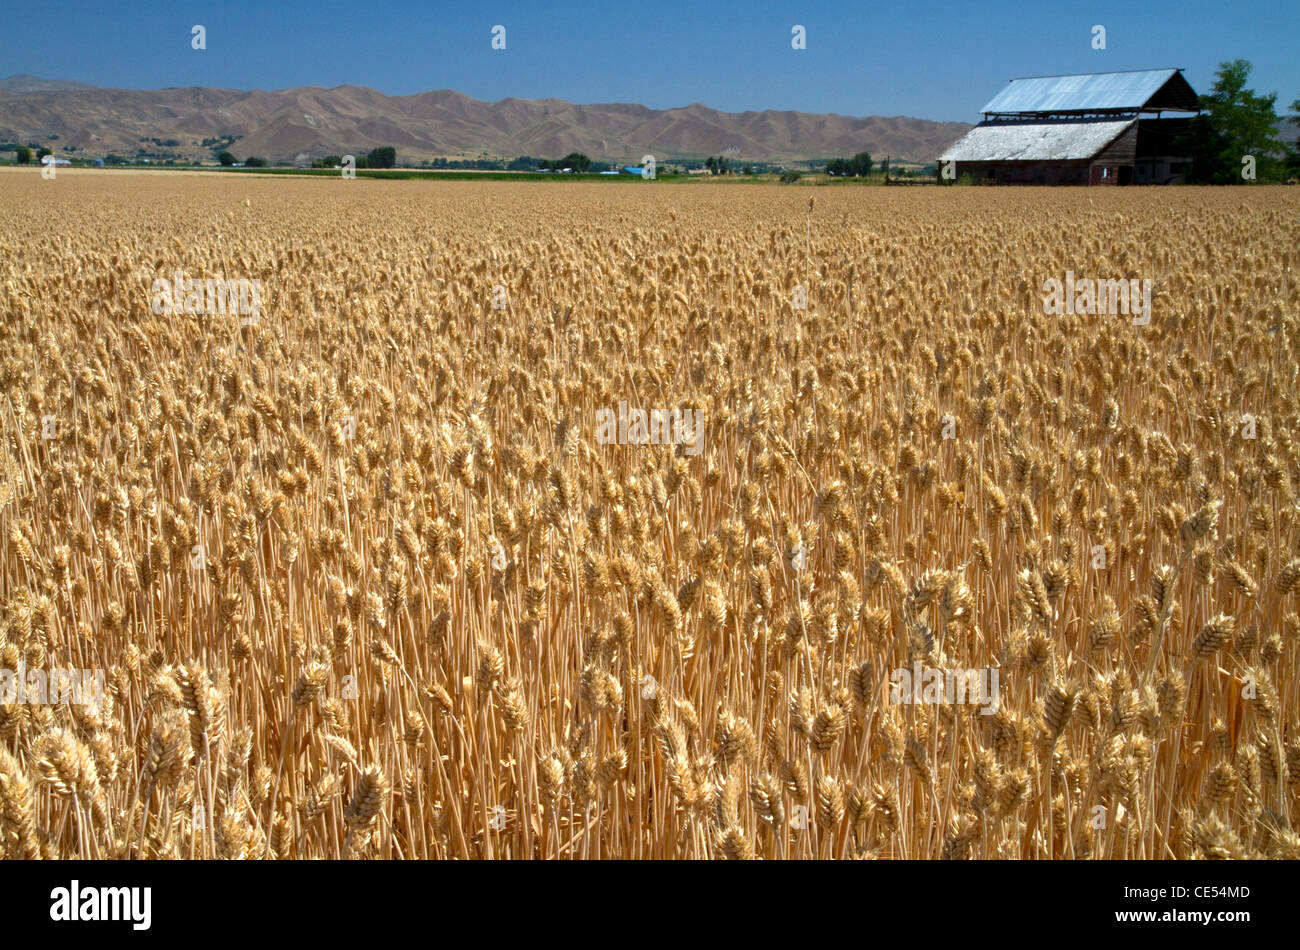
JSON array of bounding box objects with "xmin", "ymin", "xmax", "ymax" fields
[{"xmin": 0, "ymin": 75, "xmax": 971, "ymax": 162}]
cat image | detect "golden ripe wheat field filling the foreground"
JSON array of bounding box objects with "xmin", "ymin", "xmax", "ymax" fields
[{"xmin": 0, "ymin": 170, "xmax": 1300, "ymax": 859}]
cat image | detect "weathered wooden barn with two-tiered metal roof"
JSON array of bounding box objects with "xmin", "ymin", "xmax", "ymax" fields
[{"xmin": 939, "ymin": 69, "xmax": 1200, "ymax": 185}]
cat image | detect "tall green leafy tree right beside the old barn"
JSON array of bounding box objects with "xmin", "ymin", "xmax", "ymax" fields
[{"xmin": 1175, "ymin": 60, "xmax": 1282, "ymax": 185}]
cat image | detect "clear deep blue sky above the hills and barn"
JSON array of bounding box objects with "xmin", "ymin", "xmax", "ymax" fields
[{"xmin": 0, "ymin": 0, "xmax": 1300, "ymax": 121}]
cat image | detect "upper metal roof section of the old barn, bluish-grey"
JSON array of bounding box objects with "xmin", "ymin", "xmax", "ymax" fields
[{"xmin": 980, "ymin": 69, "xmax": 1197, "ymax": 114}]
